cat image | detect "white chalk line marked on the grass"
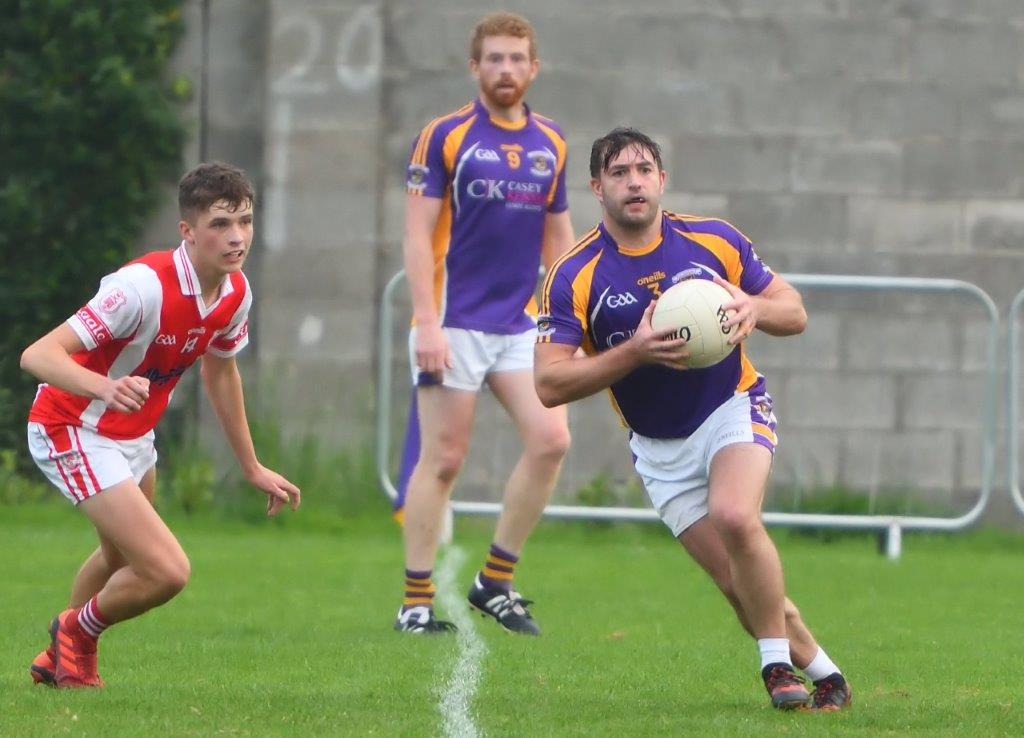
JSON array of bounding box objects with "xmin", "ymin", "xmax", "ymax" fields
[{"xmin": 437, "ymin": 546, "xmax": 487, "ymax": 738}]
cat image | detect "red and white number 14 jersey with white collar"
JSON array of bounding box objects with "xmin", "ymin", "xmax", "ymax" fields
[{"xmin": 29, "ymin": 243, "xmax": 252, "ymax": 440}]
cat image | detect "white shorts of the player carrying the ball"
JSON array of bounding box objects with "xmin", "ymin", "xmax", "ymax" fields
[{"xmin": 630, "ymin": 392, "xmax": 778, "ymax": 536}]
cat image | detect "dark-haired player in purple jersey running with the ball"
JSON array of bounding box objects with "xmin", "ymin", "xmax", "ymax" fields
[{"xmin": 535, "ymin": 128, "xmax": 851, "ymax": 710}]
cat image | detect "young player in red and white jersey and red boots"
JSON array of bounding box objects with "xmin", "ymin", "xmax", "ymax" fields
[{"xmin": 22, "ymin": 163, "xmax": 300, "ymax": 687}]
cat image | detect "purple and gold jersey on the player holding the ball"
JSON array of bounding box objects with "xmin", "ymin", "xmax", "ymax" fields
[{"xmin": 538, "ymin": 212, "xmax": 774, "ymax": 438}]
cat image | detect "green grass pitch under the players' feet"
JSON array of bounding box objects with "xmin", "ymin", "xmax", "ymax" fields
[{"xmin": 0, "ymin": 506, "xmax": 1024, "ymax": 737}]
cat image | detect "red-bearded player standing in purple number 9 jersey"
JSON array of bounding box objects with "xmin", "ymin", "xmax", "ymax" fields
[{"xmin": 395, "ymin": 12, "xmax": 573, "ymax": 635}]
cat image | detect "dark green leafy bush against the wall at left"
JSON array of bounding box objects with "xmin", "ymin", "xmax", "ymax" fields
[{"xmin": 0, "ymin": 0, "xmax": 188, "ymax": 464}]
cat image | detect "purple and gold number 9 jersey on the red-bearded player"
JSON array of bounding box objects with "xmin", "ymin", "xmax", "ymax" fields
[{"xmin": 406, "ymin": 99, "xmax": 568, "ymax": 335}]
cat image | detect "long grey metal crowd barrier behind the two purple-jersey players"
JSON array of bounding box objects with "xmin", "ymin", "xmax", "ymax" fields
[{"xmin": 377, "ymin": 271, "xmax": 999, "ymax": 559}]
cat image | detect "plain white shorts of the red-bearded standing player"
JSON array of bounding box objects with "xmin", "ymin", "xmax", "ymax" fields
[{"xmin": 409, "ymin": 325, "xmax": 537, "ymax": 392}]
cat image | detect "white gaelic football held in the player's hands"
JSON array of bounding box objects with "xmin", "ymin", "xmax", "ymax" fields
[{"xmin": 650, "ymin": 279, "xmax": 736, "ymax": 368}]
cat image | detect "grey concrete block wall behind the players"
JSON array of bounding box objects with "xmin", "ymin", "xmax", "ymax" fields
[{"xmin": 151, "ymin": 0, "xmax": 1024, "ymax": 517}]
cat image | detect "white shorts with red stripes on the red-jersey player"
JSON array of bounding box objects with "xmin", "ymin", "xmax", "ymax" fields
[{"xmin": 29, "ymin": 423, "xmax": 157, "ymax": 505}]
